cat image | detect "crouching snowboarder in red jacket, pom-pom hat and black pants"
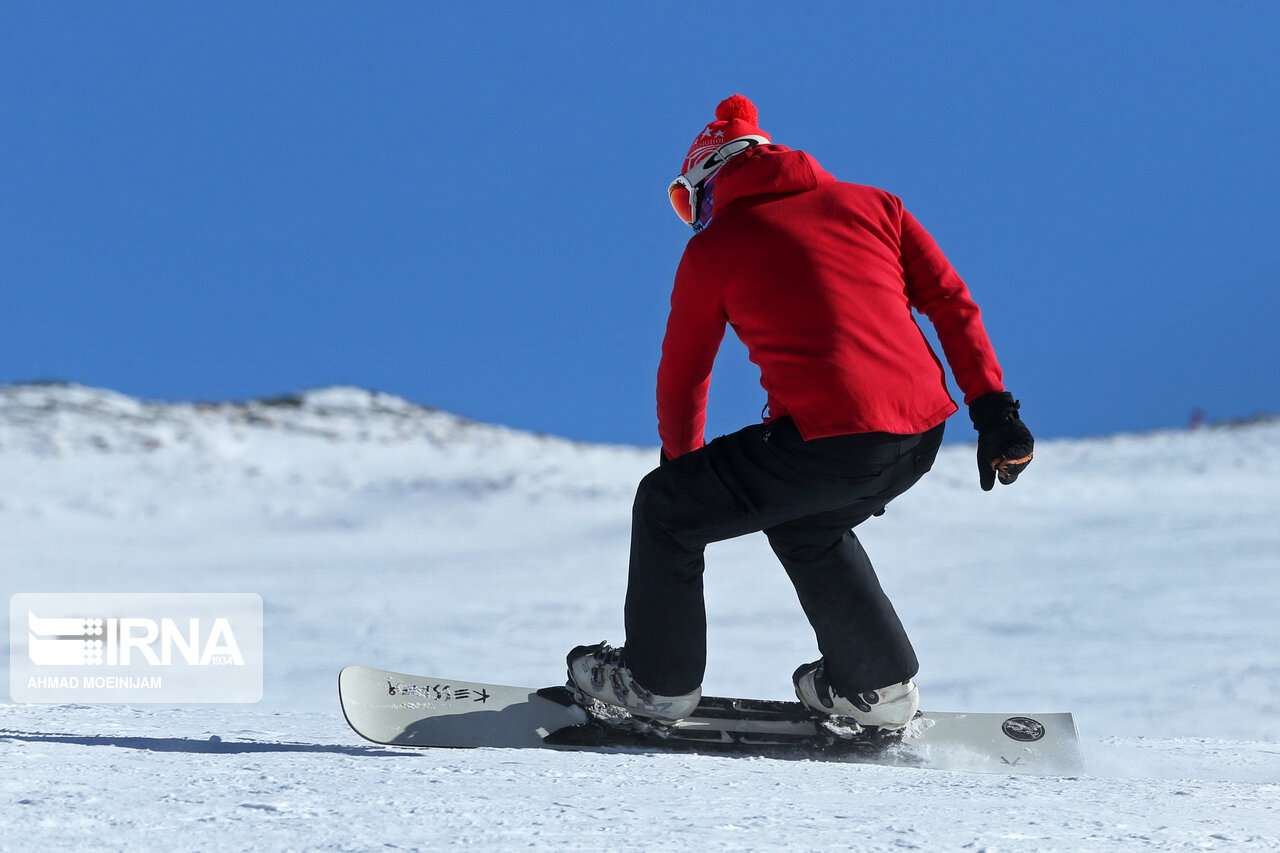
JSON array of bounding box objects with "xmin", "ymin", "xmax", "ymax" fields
[{"xmin": 568, "ymin": 95, "xmax": 1033, "ymax": 730}]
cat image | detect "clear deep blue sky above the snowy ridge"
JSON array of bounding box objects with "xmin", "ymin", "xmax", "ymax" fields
[{"xmin": 0, "ymin": 0, "xmax": 1280, "ymax": 444}]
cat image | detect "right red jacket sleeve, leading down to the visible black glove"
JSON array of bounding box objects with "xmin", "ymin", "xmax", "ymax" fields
[{"xmin": 901, "ymin": 210, "xmax": 1005, "ymax": 403}]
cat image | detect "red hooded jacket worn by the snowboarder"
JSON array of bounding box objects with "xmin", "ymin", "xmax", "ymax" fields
[{"xmin": 658, "ymin": 145, "xmax": 1004, "ymax": 459}]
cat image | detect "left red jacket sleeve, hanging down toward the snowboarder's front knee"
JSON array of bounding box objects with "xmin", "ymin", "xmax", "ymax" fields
[{"xmin": 658, "ymin": 254, "xmax": 726, "ymax": 459}]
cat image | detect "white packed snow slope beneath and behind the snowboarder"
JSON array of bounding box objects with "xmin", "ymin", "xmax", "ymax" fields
[{"xmin": 0, "ymin": 386, "xmax": 1280, "ymax": 850}]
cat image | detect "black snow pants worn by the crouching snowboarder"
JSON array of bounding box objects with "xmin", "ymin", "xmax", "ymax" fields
[{"xmin": 626, "ymin": 418, "xmax": 942, "ymax": 695}]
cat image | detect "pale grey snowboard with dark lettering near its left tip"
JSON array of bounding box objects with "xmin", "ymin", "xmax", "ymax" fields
[{"xmin": 338, "ymin": 666, "xmax": 1084, "ymax": 776}]
